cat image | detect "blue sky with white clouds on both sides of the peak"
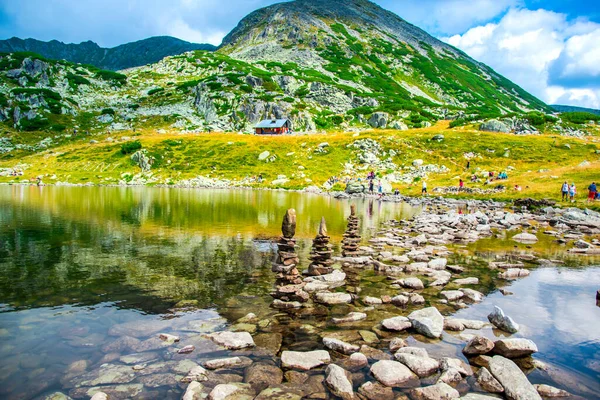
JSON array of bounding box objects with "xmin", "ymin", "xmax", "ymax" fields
[{"xmin": 0, "ymin": 0, "xmax": 600, "ymax": 108}]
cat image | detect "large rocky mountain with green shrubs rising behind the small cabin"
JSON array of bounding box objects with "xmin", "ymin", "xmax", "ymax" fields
[{"xmin": 0, "ymin": 0, "xmax": 572, "ymax": 133}]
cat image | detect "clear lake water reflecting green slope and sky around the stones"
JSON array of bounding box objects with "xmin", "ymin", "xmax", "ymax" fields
[{"xmin": 0, "ymin": 186, "xmax": 600, "ymax": 399}]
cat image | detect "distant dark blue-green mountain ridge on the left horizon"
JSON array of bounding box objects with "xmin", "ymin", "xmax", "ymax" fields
[{"xmin": 0, "ymin": 36, "xmax": 215, "ymax": 71}]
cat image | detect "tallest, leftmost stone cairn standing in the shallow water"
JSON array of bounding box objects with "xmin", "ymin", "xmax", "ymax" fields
[{"xmin": 271, "ymin": 209, "xmax": 310, "ymax": 309}]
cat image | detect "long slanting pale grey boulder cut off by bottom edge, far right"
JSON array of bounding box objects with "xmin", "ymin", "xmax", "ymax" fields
[{"xmin": 490, "ymin": 356, "xmax": 542, "ymax": 400}]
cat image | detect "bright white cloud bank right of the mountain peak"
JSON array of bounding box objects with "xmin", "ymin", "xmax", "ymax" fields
[{"xmin": 442, "ymin": 8, "xmax": 600, "ymax": 108}]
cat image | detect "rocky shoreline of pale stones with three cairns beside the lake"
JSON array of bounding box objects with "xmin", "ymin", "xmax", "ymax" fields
[{"xmin": 42, "ymin": 198, "xmax": 600, "ymax": 400}]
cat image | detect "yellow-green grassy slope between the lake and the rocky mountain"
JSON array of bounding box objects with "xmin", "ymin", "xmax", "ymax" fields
[{"xmin": 0, "ymin": 122, "xmax": 600, "ymax": 205}]
